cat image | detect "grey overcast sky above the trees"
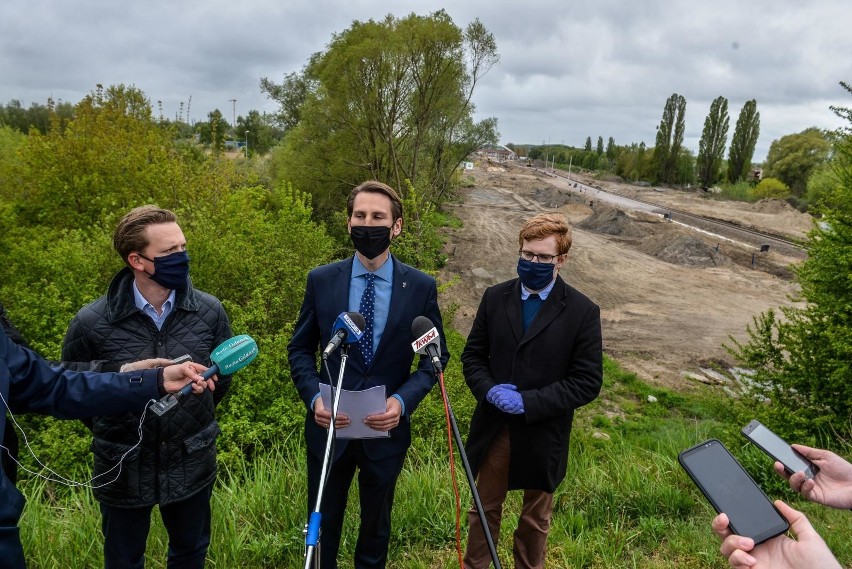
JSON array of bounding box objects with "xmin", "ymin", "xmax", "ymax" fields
[{"xmin": 0, "ymin": 0, "xmax": 852, "ymax": 160}]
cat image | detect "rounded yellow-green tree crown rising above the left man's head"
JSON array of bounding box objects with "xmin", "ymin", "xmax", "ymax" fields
[{"xmin": 12, "ymin": 85, "xmax": 213, "ymax": 227}]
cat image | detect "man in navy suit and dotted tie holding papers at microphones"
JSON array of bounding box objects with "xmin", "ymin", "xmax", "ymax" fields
[{"xmin": 288, "ymin": 181, "xmax": 449, "ymax": 569}]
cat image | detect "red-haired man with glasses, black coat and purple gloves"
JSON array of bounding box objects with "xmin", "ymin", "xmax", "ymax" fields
[{"xmin": 461, "ymin": 214, "xmax": 603, "ymax": 569}]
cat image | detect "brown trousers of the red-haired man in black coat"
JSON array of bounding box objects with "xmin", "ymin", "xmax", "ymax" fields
[{"xmin": 464, "ymin": 428, "xmax": 553, "ymax": 569}]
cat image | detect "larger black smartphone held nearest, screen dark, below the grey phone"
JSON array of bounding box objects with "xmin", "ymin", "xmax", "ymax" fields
[{"xmin": 677, "ymin": 439, "xmax": 790, "ymax": 543}]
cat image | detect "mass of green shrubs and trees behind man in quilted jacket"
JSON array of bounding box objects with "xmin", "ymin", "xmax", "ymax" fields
[{"xmin": 0, "ymin": 86, "xmax": 340, "ymax": 478}]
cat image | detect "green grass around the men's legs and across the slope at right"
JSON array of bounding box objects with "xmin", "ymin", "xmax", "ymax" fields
[{"xmin": 15, "ymin": 358, "xmax": 852, "ymax": 569}]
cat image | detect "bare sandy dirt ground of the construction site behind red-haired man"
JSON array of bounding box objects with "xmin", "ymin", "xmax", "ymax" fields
[{"xmin": 441, "ymin": 165, "xmax": 810, "ymax": 388}]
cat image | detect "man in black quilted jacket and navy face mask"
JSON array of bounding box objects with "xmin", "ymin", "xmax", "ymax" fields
[{"xmin": 62, "ymin": 205, "xmax": 232, "ymax": 568}]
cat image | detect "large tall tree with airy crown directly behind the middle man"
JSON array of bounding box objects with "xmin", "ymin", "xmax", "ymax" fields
[{"xmin": 264, "ymin": 10, "xmax": 498, "ymax": 214}]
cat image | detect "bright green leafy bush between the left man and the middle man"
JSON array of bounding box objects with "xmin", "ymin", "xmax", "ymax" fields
[{"xmin": 184, "ymin": 184, "xmax": 332, "ymax": 464}]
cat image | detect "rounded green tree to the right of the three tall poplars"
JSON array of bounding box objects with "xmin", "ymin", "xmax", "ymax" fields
[{"xmin": 763, "ymin": 127, "xmax": 831, "ymax": 196}]
